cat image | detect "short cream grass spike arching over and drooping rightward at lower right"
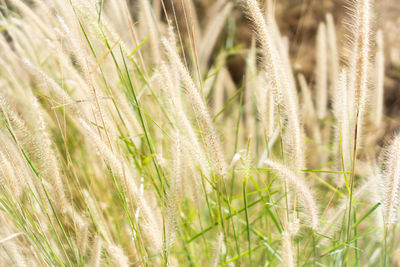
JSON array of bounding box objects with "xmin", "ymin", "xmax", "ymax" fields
[{"xmin": 264, "ymin": 159, "xmax": 319, "ymax": 230}]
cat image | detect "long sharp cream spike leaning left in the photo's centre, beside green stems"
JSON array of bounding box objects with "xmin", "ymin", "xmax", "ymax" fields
[{"xmin": 161, "ymin": 36, "xmax": 226, "ymax": 176}]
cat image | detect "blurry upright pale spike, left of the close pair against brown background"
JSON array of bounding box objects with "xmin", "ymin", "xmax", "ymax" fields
[{"xmin": 315, "ymin": 22, "xmax": 328, "ymax": 119}]
